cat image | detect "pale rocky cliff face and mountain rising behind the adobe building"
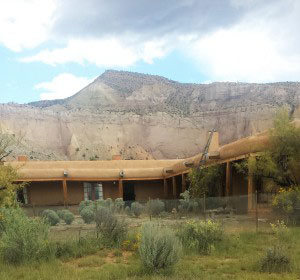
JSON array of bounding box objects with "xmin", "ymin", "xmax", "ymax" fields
[{"xmin": 0, "ymin": 71, "xmax": 300, "ymax": 160}]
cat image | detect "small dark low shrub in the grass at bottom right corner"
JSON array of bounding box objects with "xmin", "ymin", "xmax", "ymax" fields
[{"xmin": 260, "ymin": 247, "xmax": 291, "ymax": 273}]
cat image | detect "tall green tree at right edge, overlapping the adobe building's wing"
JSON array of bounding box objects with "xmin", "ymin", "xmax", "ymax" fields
[{"xmin": 235, "ymin": 109, "xmax": 300, "ymax": 188}]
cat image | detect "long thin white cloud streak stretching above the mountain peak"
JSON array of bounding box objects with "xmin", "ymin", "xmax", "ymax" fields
[{"xmin": 21, "ymin": 38, "xmax": 167, "ymax": 67}]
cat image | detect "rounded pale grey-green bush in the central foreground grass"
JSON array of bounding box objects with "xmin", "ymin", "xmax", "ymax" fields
[{"xmin": 139, "ymin": 223, "xmax": 181, "ymax": 272}]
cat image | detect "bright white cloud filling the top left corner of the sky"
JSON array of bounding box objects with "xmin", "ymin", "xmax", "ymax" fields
[{"xmin": 0, "ymin": 0, "xmax": 57, "ymax": 51}]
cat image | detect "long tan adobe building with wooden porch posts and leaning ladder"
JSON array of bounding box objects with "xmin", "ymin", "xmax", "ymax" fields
[{"xmin": 5, "ymin": 132, "xmax": 268, "ymax": 209}]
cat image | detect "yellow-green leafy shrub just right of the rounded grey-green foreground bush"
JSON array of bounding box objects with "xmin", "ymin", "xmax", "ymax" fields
[{"xmin": 178, "ymin": 220, "xmax": 223, "ymax": 254}]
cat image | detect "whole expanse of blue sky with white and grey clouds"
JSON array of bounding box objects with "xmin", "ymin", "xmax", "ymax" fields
[{"xmin": 0, "ymin": 0, "xmax": 300, "ymax": 103}]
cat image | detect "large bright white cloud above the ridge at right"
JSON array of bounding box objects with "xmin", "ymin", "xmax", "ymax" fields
[{"xmin": 183, "ymin": 0, "xmax": 300, "ymax": 82}]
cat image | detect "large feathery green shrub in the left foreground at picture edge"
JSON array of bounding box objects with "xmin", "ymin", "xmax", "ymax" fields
[{"xmin": 0, "ymin": 209, "xmax": 55, "ymax": 264}]
